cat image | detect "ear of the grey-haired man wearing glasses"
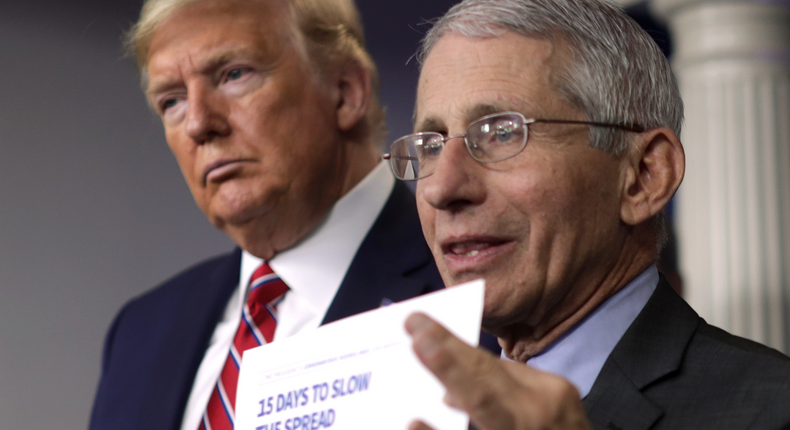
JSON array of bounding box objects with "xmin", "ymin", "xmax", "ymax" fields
[{"xmin": 620, "ymin": 127, "xmax": 686, "ymax": 225}]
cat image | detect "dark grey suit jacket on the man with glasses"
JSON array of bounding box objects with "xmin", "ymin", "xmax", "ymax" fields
[{"xmin": 584, "ymin": 276, "xmax": 790, "ymax": 430}]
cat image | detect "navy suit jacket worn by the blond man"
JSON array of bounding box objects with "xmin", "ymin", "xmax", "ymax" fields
[{"xmin": 90, "ymin": 183, "xmax": 452, "ymax": 430}]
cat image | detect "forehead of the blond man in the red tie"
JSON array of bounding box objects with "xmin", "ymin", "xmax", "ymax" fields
[{"xmin": 146, "ymin": 0, "xmax": 291, "ymax": 82}]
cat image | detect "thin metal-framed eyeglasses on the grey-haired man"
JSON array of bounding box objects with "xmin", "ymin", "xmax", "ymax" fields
[{"xmin": 383, "ymin": 112, "xmax": 645, "ymax": 181}]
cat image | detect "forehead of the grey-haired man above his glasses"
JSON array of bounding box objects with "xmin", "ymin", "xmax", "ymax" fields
[{"xmin": 416, "ymin": 32, "xmax": 572, "ymax": 128}]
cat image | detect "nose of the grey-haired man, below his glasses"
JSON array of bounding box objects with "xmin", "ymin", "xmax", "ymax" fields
[{"xmin": 417, "ymin": 136, "xmax": 485, "ymax": 212}]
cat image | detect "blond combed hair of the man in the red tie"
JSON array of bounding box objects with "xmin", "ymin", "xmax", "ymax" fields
[{"xmin": 124, "ymin": 0, "xmax": 386, "ymax": 148}]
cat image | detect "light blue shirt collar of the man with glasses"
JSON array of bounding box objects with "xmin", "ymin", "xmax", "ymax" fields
[{"xmin": 527, "ymin": 265, "xmax": 658, "ymax": 398}]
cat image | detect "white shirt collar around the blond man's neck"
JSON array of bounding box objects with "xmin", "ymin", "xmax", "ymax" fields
[{"xmin": 241, "ymin": 161, "xmax": 395, "ymax": 313}]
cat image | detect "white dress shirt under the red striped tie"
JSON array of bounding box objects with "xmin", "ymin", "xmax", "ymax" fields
[{"xmin": 181, "ymin": 161, "xmax": 395, "ymax": 430}]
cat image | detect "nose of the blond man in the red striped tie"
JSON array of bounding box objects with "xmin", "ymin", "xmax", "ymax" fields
[{"xmin": 185, "ymin": 84, "xmax": 231, "ymax": 145}]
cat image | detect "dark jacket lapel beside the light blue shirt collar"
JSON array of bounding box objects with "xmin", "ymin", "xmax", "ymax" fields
[{"xmin": 584, "ymin": 276, "xmax": 699, "ymax": 430}]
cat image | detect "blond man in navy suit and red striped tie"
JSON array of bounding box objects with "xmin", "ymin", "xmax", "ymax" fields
[{"xmin": 90, "ymin": 0, "xmax": 452, "ymax": 430}]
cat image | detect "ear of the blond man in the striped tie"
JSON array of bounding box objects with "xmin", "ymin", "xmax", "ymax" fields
[{"xmin": 337, "ymin": 64, "xmax": 371, "ymax": 131}]
